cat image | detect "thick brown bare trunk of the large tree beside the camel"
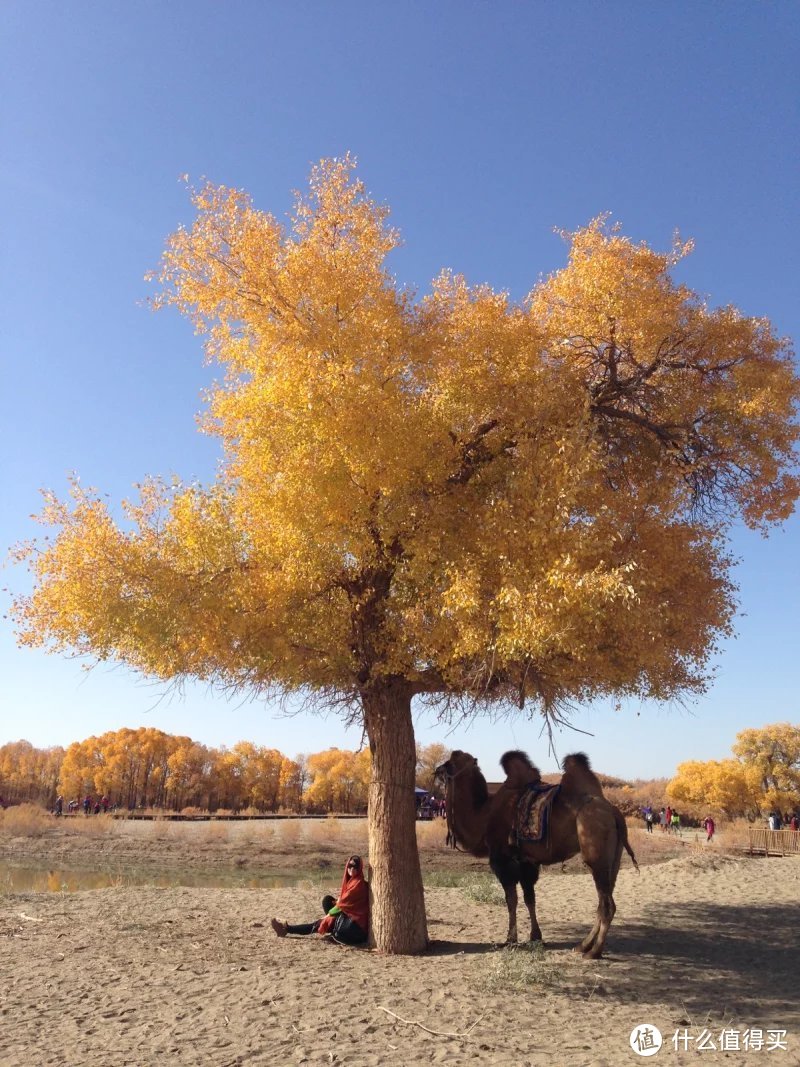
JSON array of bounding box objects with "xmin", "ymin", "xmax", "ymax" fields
[{"xmin": 363, "ymin": 683, "xmax": 428, "ymax": 954}]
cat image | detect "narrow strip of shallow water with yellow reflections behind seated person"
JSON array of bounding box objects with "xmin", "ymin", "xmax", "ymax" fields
[{"xmin": 0, "ymin": 863, "xmax": 305, "ymax": 893}]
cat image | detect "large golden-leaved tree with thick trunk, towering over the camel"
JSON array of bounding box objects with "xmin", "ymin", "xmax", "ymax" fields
[{"xmin": 15, "ymin": 158, "xmax": 798, "ymax": 953}]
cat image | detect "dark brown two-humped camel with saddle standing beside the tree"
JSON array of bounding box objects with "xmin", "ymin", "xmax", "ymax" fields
[{"xmin": 436, "ymin": 750, "xmax": 638, "ymax": 959}]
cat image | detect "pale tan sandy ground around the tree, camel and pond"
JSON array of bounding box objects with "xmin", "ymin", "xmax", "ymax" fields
[{"xmin": 0, "ymin": 828, "xmax": 800, "ymax": 1067}]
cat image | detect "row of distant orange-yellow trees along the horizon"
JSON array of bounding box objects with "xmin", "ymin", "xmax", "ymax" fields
[{"xmin": 0, "ymin": 722, "xmax": 800, "ymax": 819}]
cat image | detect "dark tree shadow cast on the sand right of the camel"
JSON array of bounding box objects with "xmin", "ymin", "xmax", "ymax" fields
[{"xmin": 547, "ymin": 903, "xmax": 800, "ymax": 1026}]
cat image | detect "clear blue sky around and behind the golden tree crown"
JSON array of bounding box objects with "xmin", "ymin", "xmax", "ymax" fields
[{"xmin": 0, "ymin": 0, "xmax": 800, "ymax": 778}]
